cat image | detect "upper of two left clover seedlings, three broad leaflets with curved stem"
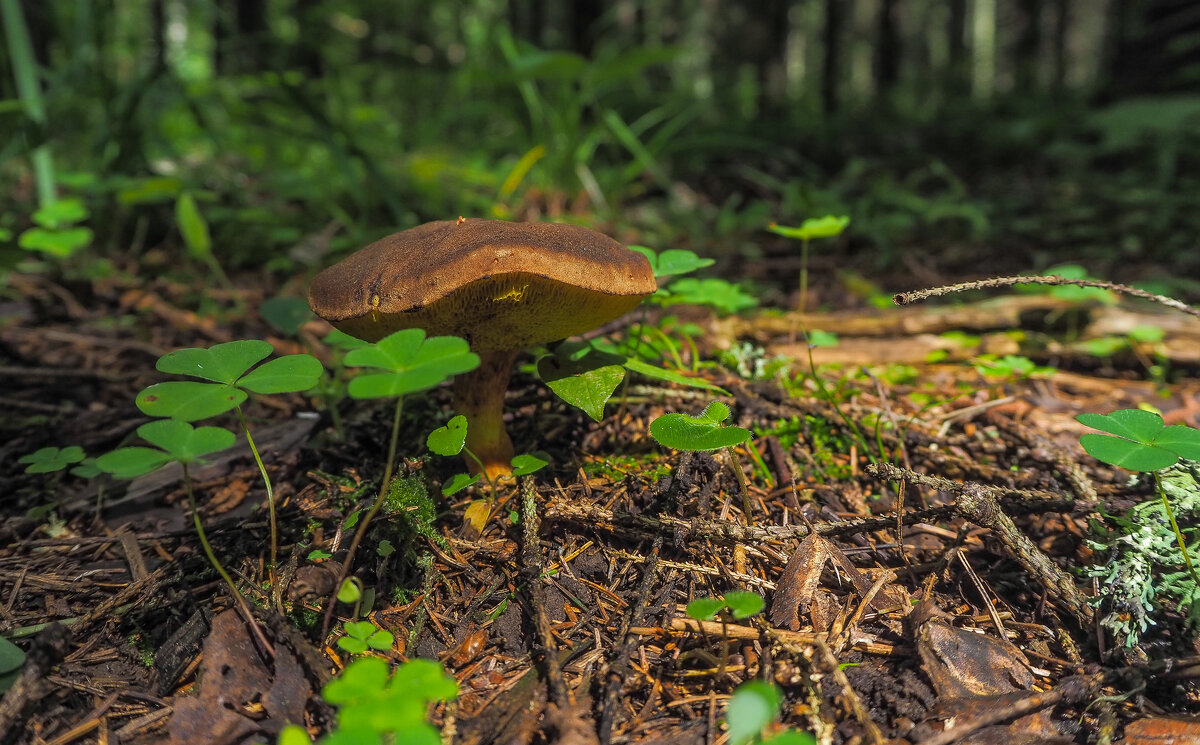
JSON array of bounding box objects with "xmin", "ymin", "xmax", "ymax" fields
[{"xmin": 136, "ymin": 340, "xmax": 325, "ymax": 607}]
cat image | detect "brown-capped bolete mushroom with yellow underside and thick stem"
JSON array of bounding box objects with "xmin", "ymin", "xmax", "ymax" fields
[{"xmin": 308, "ymin": 217, "xmax": 658, "ymax": 479}]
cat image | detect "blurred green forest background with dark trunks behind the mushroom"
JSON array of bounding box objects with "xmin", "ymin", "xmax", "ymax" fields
[{"xmin": 0, "ymin": 0, "xmax": 1200, "ymax": 298}]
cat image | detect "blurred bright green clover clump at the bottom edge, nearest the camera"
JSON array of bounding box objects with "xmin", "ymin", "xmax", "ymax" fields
[{"xmin": 278, "ymin": 656, "xmax": 458, "ymax": 745}]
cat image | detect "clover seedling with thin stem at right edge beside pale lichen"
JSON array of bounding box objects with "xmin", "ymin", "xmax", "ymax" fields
[{"xmin": 1075, "ymin": 409, "xmax": 1200, "ymax": 582}]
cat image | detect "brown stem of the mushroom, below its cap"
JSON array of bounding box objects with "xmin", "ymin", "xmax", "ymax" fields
[{"xmin": 454, "ymin": 349, "xmax": 520, "ymax": 480}]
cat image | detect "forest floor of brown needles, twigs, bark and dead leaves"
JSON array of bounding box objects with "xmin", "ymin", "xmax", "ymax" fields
[{"xmin": 0, "ymin": 259, "xmax": 1200, "ymax": 745}]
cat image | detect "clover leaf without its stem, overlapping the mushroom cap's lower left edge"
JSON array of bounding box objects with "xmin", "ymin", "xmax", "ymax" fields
[{"xmin": 346, "ymin": 329, "xmax": 479, "ymax": 398}]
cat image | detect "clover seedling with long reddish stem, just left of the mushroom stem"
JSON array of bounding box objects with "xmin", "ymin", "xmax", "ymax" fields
[{"xmin": 322, "ymin": 329, "xmax": 479, "ymax": 636}]
